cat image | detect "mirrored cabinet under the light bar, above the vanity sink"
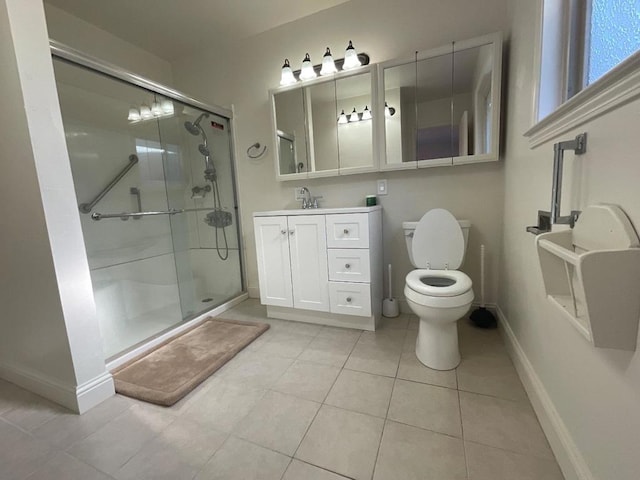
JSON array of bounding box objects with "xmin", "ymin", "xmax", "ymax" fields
[{"xmin": 271, "ymin": 67, "xmax": 378, "ymax": 180}]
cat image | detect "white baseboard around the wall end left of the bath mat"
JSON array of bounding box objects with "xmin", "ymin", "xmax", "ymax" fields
[{"xmin": 0, "ymin": 363, "xmax": 115, "ymax": 413}]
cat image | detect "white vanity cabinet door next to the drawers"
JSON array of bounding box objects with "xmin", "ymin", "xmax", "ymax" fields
[{"xmin": 288, "ymin": 215, "xmax": 329, "ymax": 312}]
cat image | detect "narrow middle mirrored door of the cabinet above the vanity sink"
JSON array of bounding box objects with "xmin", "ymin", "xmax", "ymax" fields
[{"xmin": 304, "ymin": 79, "xmax": 339, "ymax": 177}]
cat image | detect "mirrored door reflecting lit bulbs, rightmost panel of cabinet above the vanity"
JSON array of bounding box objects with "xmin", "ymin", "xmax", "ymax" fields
[{"xmin": 336, "ymin": 67, "xmax": 377, "ymax": 175}]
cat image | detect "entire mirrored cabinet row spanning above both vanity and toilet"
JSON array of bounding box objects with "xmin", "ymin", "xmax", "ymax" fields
[{"xmin": 270, "ymin": 33, "xmax": 502, "ymax": 180}]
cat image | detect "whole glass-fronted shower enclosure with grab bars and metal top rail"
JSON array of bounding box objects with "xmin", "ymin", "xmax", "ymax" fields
[{"xmin": 52, "ymin": 42, "xmax": 244, "ymax": 359}]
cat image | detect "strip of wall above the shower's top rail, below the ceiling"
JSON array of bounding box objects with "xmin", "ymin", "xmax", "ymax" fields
[{"xmin": 44, "ymin": 3, "xmax": 172, "ymax": 85}]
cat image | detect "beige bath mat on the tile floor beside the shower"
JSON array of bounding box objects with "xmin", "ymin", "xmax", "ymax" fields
[{"xmin": 113, "ymin": 317, "xmax": 269, "ymax": 406}]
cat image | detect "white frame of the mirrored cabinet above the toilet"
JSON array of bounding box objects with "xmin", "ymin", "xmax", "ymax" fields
[{"xmin": 377, "ymin": 32, "xmax": 502, "ymax": 171}]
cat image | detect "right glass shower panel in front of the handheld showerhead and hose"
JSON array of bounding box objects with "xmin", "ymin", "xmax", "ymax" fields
[{"xmin": 160, "ymin": 100, "xmax": 242, "ymax": 318}]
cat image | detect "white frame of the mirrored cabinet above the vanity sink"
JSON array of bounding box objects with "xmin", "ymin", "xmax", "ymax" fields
[{"xmin": 269, "ymin": 64, "xmax": 384, "ymax": 182}]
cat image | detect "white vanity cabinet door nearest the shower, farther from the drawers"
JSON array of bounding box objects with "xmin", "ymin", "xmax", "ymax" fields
[{"xmin": 253, "ymin": 216, "xmax": 293, "ymax": 307}]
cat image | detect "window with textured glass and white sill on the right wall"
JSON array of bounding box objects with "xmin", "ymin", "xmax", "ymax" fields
[{"xmin": 525, "ymin": 0, "xmax": 640, "ymax": 147}]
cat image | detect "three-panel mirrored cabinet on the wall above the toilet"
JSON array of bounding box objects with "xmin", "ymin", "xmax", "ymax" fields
[{"xmin": 378, "ymin": 33, "xmax": 502, "ymax": 170}]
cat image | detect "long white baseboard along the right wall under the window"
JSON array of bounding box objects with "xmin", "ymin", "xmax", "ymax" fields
[{"xmin": 496, "ymin": 305, "xmax": 594, "ymax": 480}]
